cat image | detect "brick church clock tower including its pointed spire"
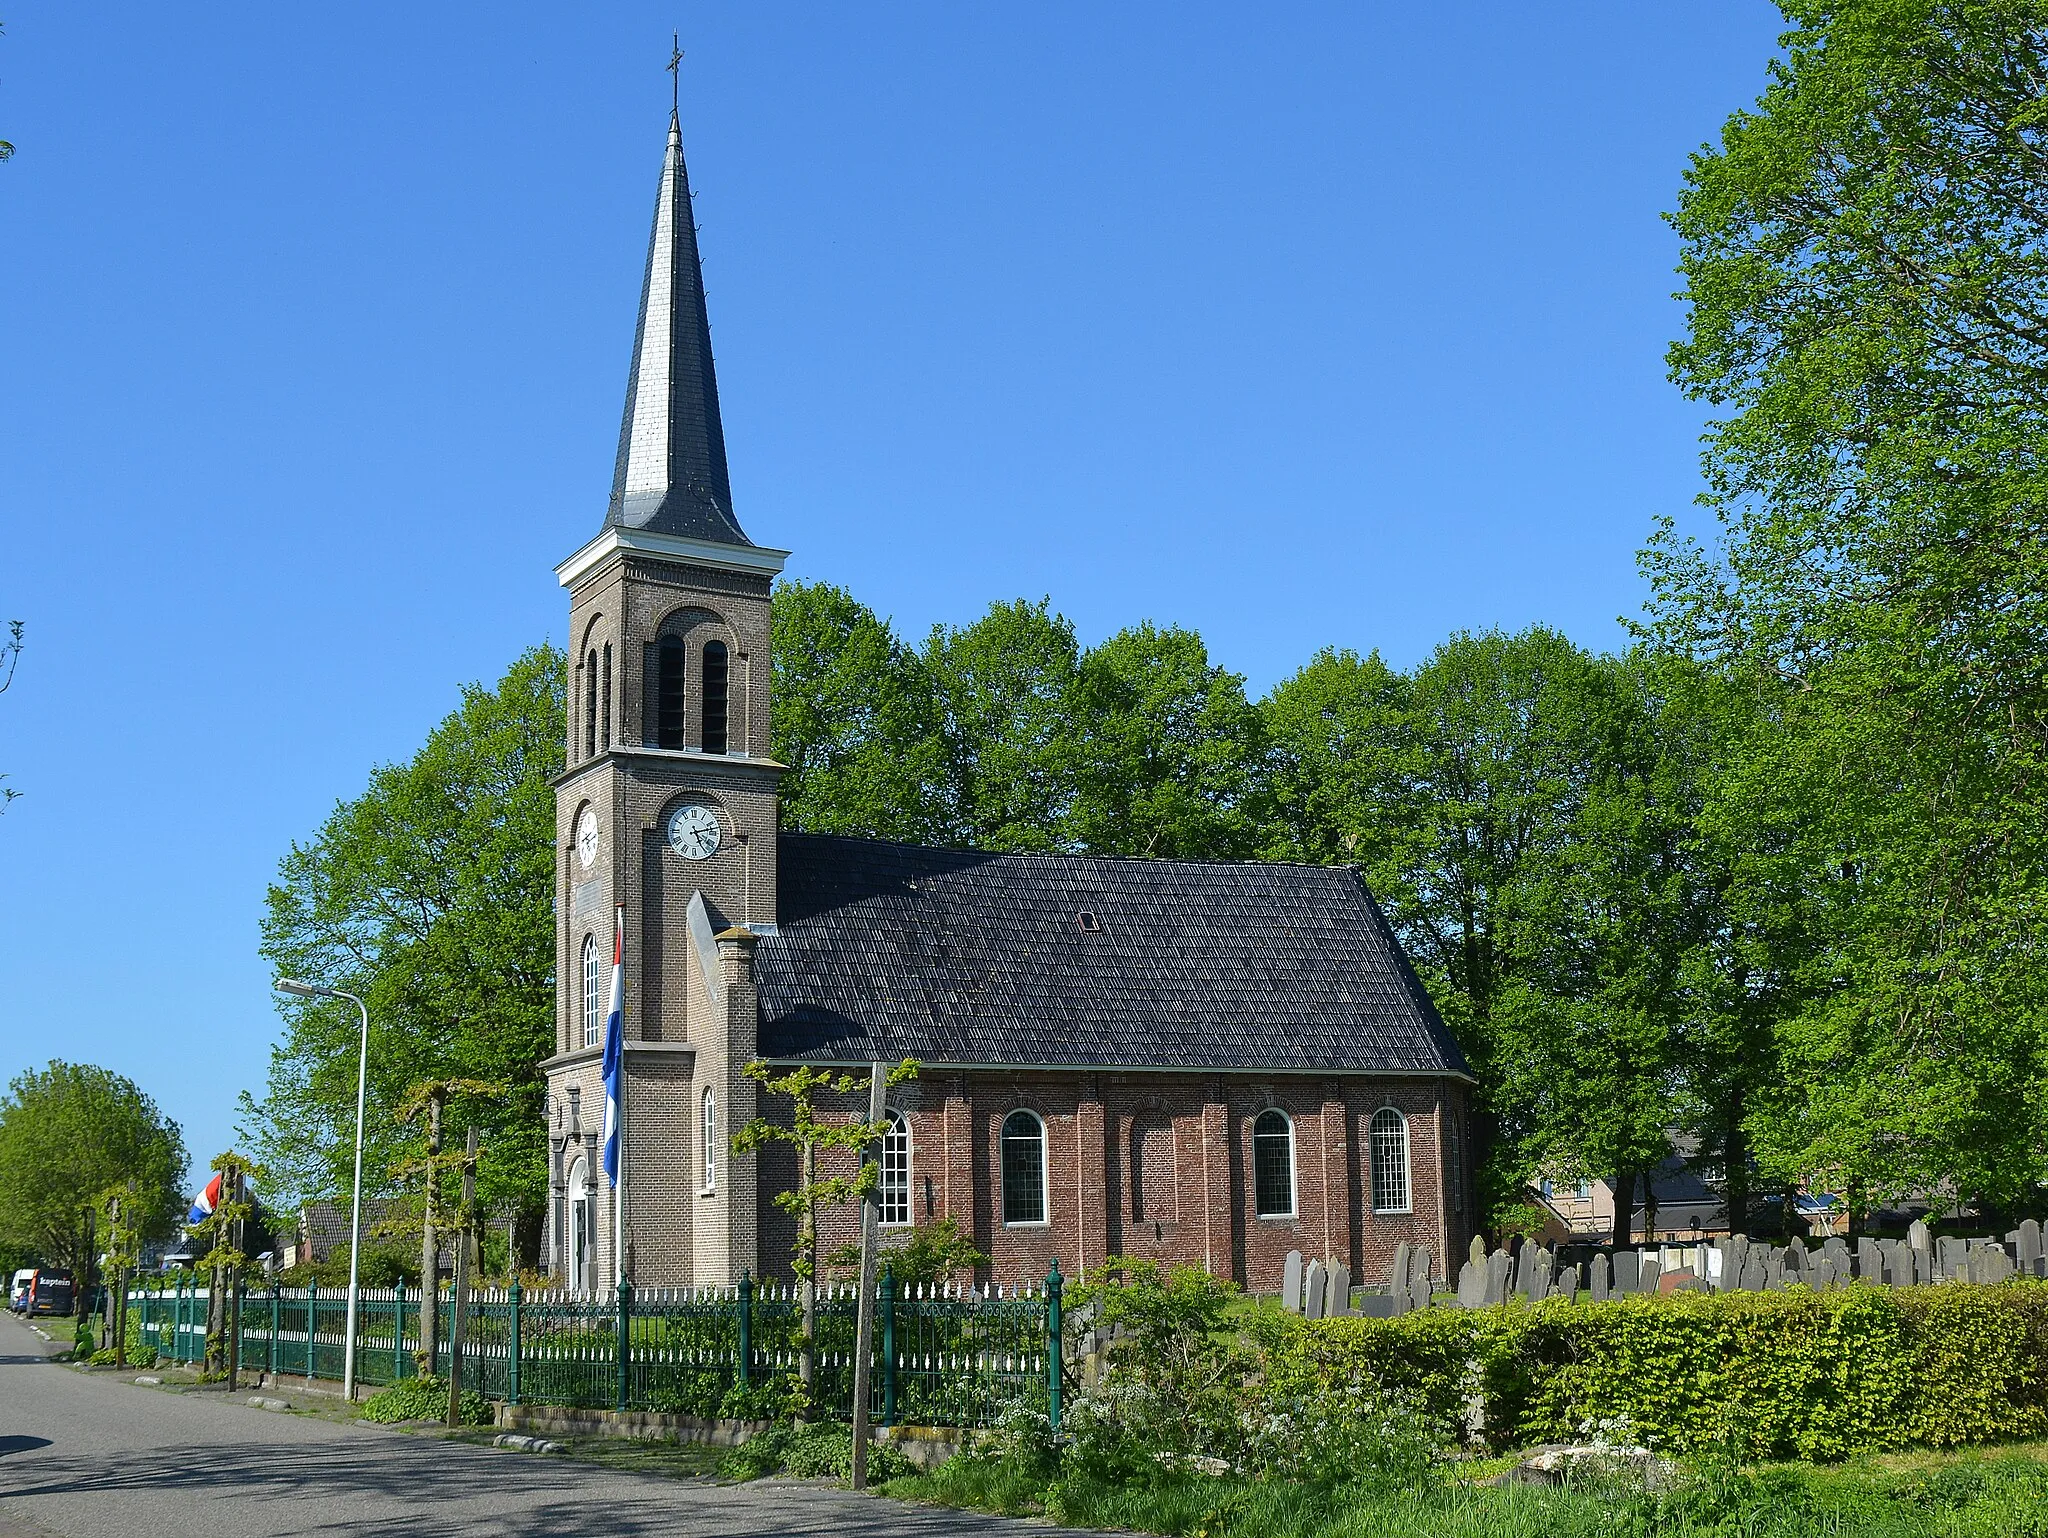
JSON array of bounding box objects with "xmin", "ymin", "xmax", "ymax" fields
[{"xmin": 547, "ymin": 105, "xmax": 786, "ymax": 1288}]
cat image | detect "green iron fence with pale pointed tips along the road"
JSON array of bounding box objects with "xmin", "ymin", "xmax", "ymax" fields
[{"xmin": 129, "ymin": 1268, "xmax": 1065, "ymax": 1425}]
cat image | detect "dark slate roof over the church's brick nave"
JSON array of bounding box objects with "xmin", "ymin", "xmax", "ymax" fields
[{"xmin": 756, "ymin": 834, "xmax": 1466, "ymax": 1073}]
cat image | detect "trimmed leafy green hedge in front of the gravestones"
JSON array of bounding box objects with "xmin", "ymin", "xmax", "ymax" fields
[{"xmin": 1260, "ymin": 1282, "xmax": 2048, "ymax": 1460}]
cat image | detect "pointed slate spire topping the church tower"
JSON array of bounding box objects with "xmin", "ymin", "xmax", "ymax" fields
[{"xmin": 604, "ymin": 111, "xmax": 754, "ymax": 545}]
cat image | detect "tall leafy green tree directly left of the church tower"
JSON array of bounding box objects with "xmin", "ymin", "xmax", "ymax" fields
[{"xmin": 244, "ymin": 647, "xmax": 565, "ymax": 1259}]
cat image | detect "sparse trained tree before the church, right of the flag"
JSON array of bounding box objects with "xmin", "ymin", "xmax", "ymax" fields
[{"xmin": 733, "ymin": 1057, "xmax": 918, "ymax": 1419}]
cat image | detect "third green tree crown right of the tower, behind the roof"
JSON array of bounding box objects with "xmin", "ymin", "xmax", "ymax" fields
[{"xmin": 1067, "ymin": 623, "xmax": 1264, "ymax": 860}]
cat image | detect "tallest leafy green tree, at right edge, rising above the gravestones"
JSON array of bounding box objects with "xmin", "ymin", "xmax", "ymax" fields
[{"xmin": 1645, "ymin": 0, "xmax": 2048, "ymax": 1206}]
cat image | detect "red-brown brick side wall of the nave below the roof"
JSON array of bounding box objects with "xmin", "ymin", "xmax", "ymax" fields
[{"xmin": 760, "ymin": 1067, "xmax": 1470, "ymax": 1292}]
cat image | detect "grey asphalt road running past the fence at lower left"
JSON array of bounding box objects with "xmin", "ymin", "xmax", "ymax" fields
[{"xmin": 0, "ymin": 1317, "xmax": 1051, "ymax": 1538}]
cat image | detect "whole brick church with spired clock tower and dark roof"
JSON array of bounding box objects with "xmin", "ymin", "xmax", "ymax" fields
[{"xmin": 545, "ymin": 105, "xmax": 1475, "ymax": 1290}]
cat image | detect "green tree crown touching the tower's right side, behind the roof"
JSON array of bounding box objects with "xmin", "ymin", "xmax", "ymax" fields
[{"xmin": 772, "ymin": 582, "xmax": 948, "ymax": 844}]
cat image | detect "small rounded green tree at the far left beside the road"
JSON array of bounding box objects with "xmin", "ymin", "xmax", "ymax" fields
[{"xmin": 0, "ymin": 1061, "xmax": 184, "ymax": 1278}]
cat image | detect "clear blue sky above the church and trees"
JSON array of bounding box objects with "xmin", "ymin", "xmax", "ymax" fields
[{"xmin": 0, "ymin": 0, "xmax": 1782, "ymax": 1169}]
